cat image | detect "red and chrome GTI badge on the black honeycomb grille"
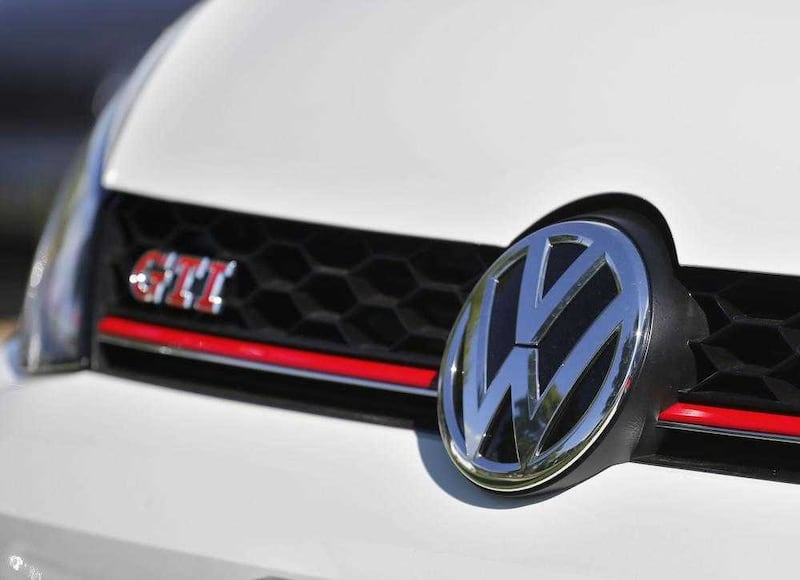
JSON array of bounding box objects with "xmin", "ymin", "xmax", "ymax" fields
[{"xmin": 128, "ymin": 250, "xmax": 236, "ymax": 314}]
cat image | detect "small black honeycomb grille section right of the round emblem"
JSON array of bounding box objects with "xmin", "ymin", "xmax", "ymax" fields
[{"xmin": 681, "ymin": 268, "xmax": 800, "ymax": 414}]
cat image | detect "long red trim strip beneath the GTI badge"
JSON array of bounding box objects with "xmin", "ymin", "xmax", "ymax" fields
[{"xmin": 97, "ymin": 316, "xmax": 436, "ymax": 389}]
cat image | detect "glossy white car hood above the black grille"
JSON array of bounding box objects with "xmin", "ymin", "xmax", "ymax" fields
[{"xmin": 104, "ymin": 0, "xmax": 800, "ymax": 274}]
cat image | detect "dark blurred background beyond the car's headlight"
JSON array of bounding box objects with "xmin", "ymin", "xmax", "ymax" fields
[{"xmin": 0, "ymin": 0, "xmax": 195, "ymax": 322}]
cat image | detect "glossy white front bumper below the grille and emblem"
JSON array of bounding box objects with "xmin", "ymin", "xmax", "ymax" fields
[{"xmin": 0, "ymin": 342, "xmax": 800, "ymax": 580}]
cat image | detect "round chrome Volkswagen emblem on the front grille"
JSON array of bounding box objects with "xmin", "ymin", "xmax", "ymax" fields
[{"xmin": 439, "ymin": 221, "xmax": 650, "ymax": 491}]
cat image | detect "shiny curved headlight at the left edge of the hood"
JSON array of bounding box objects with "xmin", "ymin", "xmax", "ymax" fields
[{"xmin": 11, "ymin": 7, "xmax": 197, "ymax": 373}]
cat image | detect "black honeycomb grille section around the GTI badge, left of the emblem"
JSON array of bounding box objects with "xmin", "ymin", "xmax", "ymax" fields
[{"xmin": 98, "ymin": 194, "xmax": 501, "ymax": 367}]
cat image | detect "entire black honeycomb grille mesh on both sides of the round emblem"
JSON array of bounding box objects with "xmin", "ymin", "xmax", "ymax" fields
[{"xmin": 96, "ymin": 193, "xmax": 800, "ymax": 415}]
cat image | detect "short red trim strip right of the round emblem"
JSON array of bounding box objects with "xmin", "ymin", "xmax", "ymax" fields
[{"xmin": 658, "ymin": 403, "xmax": 800, "ymax": 437}]
